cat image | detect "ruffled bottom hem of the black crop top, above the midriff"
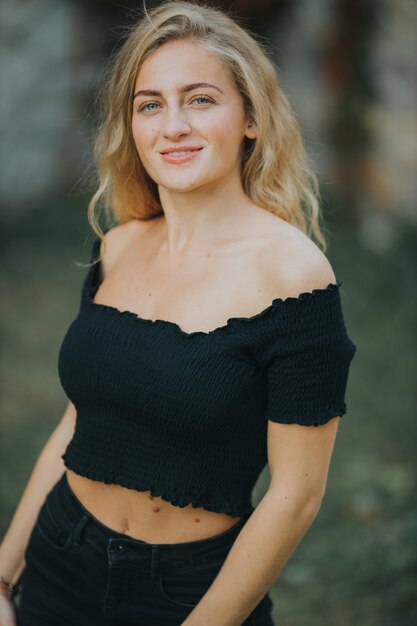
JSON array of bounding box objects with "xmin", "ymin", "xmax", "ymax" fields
[{"xmin": 61, "ymin": 454, "xmax": 254, "ymax": 517}]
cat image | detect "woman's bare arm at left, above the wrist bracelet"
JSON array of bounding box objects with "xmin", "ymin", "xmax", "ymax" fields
[{"xmin": 0, "ymin": 402, "xmax": 76, "ymax": 597}]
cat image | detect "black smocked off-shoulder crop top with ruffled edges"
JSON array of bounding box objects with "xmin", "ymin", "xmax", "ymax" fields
[{"xmin": 58, "ymin": 229, "xmax": 356, "ymax": 517}]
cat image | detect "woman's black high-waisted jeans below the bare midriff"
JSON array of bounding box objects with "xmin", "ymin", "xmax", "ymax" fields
[{"xmin": 17, "ymin": 472, "xmax": 273, "ymax": 626}]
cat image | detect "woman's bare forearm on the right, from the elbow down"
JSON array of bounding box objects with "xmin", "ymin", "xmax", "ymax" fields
[{"xmin": 183, "ymin": 490, "xmax": 319, "ymax": 626}]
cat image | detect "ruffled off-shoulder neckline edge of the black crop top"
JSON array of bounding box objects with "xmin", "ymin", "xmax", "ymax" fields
[{"xmin": 86, "ymin": 233, "xmax": 343, "ymax": 338}]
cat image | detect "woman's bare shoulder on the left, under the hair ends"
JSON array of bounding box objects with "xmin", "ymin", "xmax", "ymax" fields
[{"xmin": 100, "ymin": 219, "xmax": 155, "ymax": 278}]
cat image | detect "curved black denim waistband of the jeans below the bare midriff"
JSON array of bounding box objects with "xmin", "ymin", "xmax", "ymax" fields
[{"xmin": 49, "ymin": 471, "xmax": 250, "ymax": 565}]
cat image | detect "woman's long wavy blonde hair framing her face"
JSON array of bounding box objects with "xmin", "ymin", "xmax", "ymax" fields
[{"xmin": 83, "ymin": 1, "xmax": 327, "ymax": 260}]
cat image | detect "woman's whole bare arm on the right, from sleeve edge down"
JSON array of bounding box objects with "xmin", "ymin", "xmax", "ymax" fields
[{"xmin": 183, "ymin": 416, "xmax": 339, "ymax": 626}]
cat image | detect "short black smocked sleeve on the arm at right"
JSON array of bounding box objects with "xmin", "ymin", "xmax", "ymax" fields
[{"xmin": 261, "ymin": 279, "xmax": 356, "ymax": 426}]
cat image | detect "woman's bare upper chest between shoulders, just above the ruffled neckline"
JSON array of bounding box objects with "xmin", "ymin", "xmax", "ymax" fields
[{"xmin": 91, "ymin": 240, "xmax": 271, "ymax": 334}]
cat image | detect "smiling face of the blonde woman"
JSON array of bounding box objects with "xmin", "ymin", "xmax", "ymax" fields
[{"xmin": 132, "ymin": 41, "xmax": 255, "ymax": 192}]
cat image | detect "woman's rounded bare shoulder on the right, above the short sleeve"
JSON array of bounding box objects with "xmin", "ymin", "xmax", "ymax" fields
[{"xmin": 255, "ymin": 220, "xmax": 336, "ymax": 299}]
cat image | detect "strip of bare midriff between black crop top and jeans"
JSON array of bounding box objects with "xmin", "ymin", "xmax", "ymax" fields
[{"xmin": 66, "ymin": 469, "xmax": 240, "ymax": 543}]
